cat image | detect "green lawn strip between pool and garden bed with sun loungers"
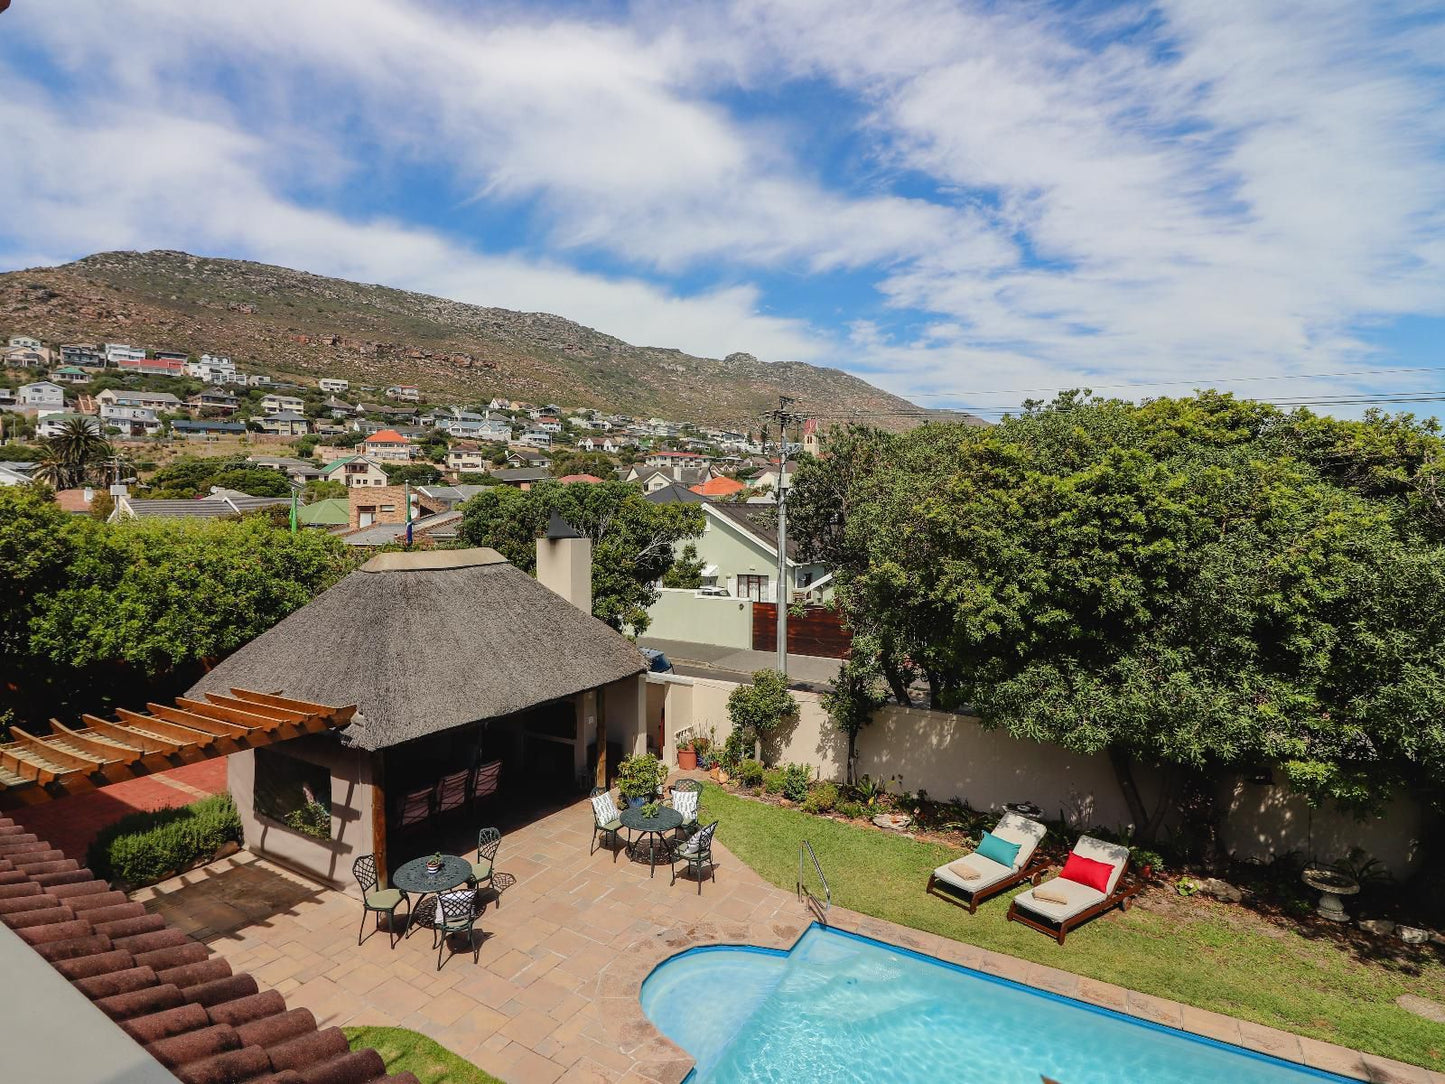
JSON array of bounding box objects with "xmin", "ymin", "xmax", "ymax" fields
[{"xmin": 702, "ymin": 783, "xmax": 1445, "ymax": 1070}]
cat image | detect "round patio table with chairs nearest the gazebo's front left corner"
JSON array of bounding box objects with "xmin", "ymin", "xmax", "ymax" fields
[{"xmin": 351, "ymin": 828, "xmax": 501, "ymax": 971}]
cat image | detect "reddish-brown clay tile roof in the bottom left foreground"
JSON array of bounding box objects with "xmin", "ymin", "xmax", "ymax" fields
[{"xmin": 0, "ymin": 818, "xmax": 418, "ymax": 1084}]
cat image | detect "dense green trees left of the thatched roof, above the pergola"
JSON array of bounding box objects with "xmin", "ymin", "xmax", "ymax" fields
[{"xmin": 0, "ymin": 486, "xmax": 351, "ymax": 724}]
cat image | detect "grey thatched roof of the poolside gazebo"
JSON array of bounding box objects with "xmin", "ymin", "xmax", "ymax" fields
[{"xmin": 189, "ymin": 549, "xmax": 647, "ymax": 749}]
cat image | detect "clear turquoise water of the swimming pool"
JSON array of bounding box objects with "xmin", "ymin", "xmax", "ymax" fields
[{"xmin": 642, "ymin": 925, "xmax": 1345, "ymax": 1084}]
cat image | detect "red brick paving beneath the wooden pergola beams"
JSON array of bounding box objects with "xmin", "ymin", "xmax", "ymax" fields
[{"xmin": 10, "ymin": 757, "xmax": 225, "ymax": 860}]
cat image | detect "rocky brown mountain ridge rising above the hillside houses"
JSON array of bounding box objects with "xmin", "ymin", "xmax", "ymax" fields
[{"xmin": 0, "ymin": 250, "xmax": 936, "ymax": 428}]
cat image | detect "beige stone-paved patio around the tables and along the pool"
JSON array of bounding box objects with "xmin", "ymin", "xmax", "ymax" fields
[{"xmin": 134, "ymin": 801, "xmax": 1445, "ymax": 1084}]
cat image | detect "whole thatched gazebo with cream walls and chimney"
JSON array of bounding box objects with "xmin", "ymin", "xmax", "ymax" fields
[{"xmin": 189, "ymin": 546, "xmax": 647, "ymax": 882}]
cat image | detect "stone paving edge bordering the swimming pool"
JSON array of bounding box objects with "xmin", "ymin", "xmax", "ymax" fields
[{"xmin": 610, "ymin": 906, "xmax": 1445, "ymax": 1084}]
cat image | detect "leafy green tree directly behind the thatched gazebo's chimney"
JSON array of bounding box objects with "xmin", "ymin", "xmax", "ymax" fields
[{"xmin": 458, "ymin": 481, "xmax": 704, "ymax": 633}]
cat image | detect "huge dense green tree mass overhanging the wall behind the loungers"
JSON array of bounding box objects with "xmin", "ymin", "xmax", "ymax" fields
[{"xmin": 790, "ymin": 393, "xmax": 1445, "ymax": 831}]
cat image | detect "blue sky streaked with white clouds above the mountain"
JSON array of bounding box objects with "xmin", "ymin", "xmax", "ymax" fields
[{"xmin": 0, "ymin": 0, "xmax": 1445, "ymax": 413}]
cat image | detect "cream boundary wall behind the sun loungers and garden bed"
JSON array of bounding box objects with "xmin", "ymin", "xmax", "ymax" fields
[{"xmin": 647, "ymin": 676, "xmax": 1420, "ymax": 876}]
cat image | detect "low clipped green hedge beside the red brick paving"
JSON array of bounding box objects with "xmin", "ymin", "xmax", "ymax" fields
[{"xmin": 85, "ymin": 793, "xmax": 242, "ymax": 887}]
